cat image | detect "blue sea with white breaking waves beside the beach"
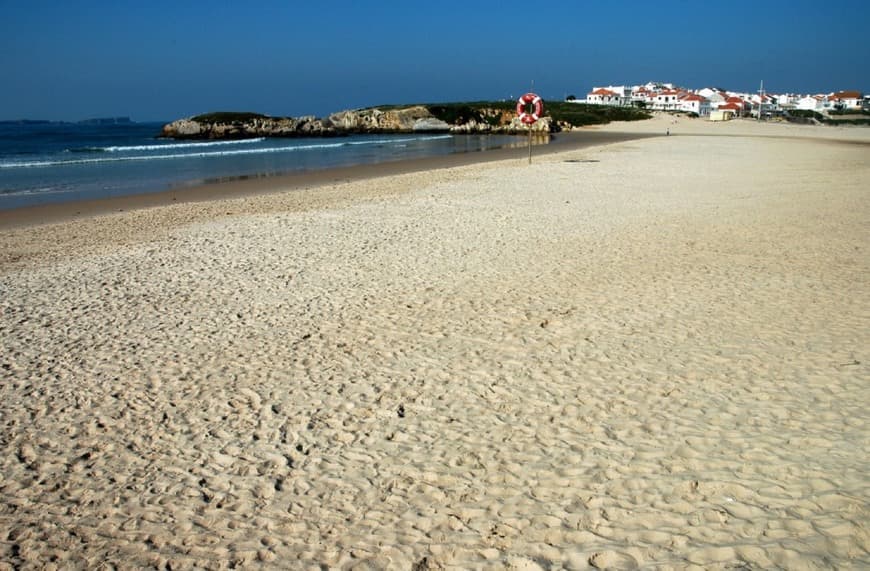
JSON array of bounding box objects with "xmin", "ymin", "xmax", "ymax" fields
[{"xmin": 0, "ymin": 123, "xmax": 522, "ymax": 210}]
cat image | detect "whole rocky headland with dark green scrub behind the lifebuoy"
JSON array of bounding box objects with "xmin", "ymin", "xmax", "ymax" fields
[{"xmin": 162, "ymin": 101, "xmax": 650, "ymax": 139}]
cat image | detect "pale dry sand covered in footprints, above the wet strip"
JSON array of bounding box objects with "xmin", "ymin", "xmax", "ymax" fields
[{"xmin": 0, "ymin": 117, "xmax": 870, "ymax": 570}]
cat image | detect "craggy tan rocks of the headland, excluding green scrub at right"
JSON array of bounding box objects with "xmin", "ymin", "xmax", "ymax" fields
[{"xmin": 162, "ymin": 105, "xmax": 557, "ymax": 139}]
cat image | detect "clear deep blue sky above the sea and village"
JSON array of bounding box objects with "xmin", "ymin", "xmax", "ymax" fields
[{"xmin": 0, "ymin": 0, "xmax": 870, "ymax": 121}]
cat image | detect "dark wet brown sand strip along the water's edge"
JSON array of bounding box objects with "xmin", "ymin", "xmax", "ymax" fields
[{"xmin": 0, "ymin": 129, "xmax": 657, "ymax": 230}]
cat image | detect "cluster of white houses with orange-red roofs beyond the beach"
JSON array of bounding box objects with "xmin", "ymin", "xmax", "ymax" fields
[{"xmin": 567, "ymin": 82, "xmax": 870, "ymax": 121}]
